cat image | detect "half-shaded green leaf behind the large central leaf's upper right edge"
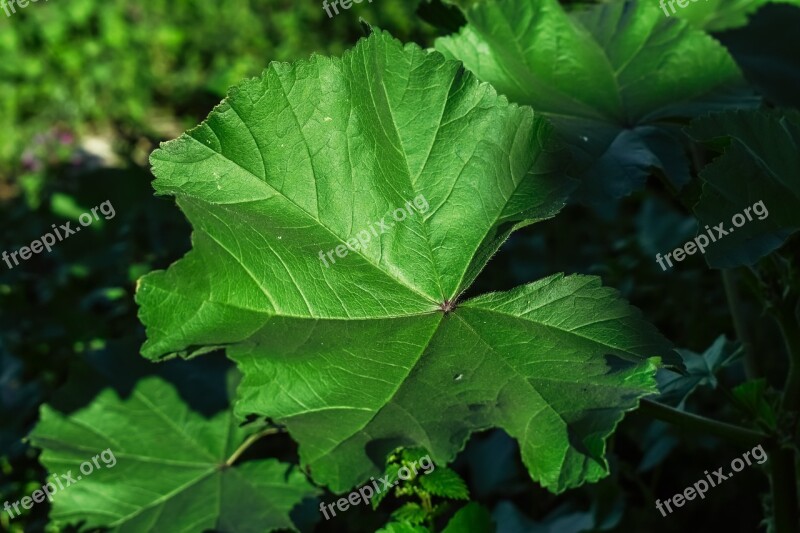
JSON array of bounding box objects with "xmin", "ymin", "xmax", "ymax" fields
[{"xmin": 436, "ymin": 0, "xmax": 755, "ymax": 205}]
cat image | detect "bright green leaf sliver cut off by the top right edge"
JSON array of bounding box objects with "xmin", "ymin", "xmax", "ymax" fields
[{"xmin": 676, "ymin": 0, "xmax": 800, "ymax": 32}]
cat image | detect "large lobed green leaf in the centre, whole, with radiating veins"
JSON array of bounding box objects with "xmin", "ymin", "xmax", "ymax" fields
[{"xmin": 137, "ymin": 33, "xmax": 671, "ymax": 491}]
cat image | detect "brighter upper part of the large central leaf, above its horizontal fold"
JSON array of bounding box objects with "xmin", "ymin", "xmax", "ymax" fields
[{"xmin": 137, "ymin": 29, "xmax": 573, "ymax": 359}]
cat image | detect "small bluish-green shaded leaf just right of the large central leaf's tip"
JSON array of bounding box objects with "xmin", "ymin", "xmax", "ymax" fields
[{"xmin": 658, "ymin": 335, "xmax": 741, "ymax": 409}]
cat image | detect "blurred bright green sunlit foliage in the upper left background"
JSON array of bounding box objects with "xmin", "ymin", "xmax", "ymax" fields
[{"xmin": 0, "ymin": 0, "xmax": 430, "ymax": 177}]
